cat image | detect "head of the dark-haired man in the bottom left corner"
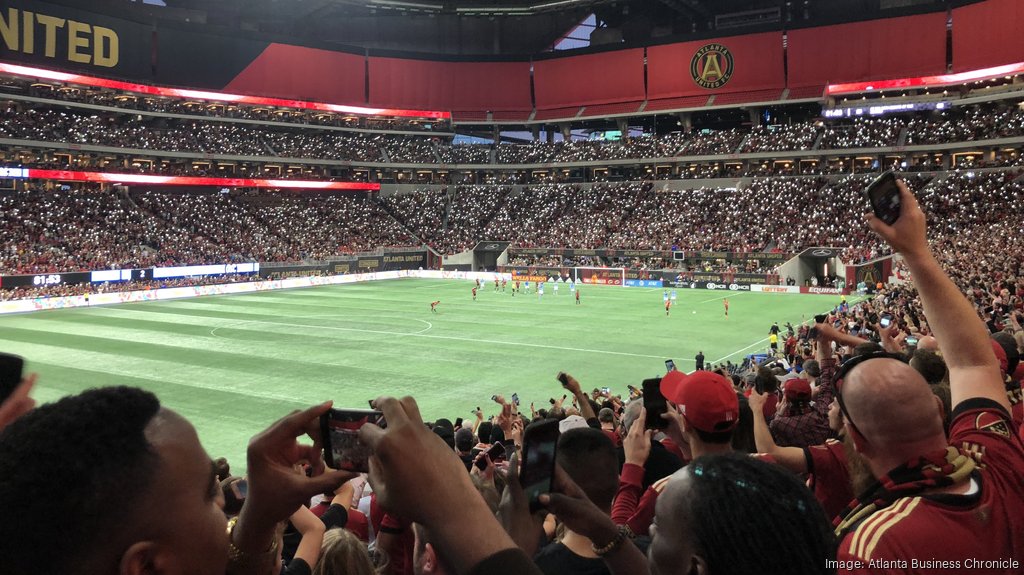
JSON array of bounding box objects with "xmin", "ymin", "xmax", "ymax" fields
[{"xmin": 0, "ymin": 388, "xmax": 227, "ymax": 575}]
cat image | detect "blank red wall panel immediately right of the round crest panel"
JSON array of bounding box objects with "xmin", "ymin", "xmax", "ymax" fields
[{"xmin": 787, "ymin": 12, "xmax": 946, "ymax": 88}]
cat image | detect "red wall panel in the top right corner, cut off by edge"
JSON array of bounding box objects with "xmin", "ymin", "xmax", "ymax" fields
[{"xmin": 953, "ymin": 0, "xmax": 1024, "ymax": 72}]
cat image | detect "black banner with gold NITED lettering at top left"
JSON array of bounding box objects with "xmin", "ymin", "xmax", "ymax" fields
[{"xmin": 0, "ymin": 0, "xmax": 153, "ymax": 79}]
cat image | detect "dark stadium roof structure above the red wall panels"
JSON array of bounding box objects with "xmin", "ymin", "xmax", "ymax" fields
[{"xmin": 75, "ymin": 0, "xmax": 979, "ymax": 56}]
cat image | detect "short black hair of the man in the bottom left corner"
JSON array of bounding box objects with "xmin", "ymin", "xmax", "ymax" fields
[{"xmin": 0, "ymin": 387, "xmax": 160, "ymax": 575}]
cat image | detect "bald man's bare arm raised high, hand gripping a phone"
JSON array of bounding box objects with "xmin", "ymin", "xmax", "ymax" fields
[{"xmin": 865, "ymin": 181, "xmax": 1010, "ymax": 411}]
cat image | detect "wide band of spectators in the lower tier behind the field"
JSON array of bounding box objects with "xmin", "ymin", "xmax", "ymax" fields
[{"xmin": 0, "ymin": 164, "xmax": 1024, "ymax": 280}]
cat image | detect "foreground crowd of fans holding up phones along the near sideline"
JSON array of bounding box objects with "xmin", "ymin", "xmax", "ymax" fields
[{"xmin": 0, "ymin": 182, "xmax": 1024, "ymax": 575}]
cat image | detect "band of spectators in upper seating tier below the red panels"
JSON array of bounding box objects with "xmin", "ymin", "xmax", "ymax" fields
[{"xmin": 6, "ymin": 98, "xmax": 1024, "ymax": 170}]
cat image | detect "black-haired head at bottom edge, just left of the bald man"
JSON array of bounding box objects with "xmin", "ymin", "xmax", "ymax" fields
[{"xmin": 648, "ymin": 454, "xmax": 836, "ymax": 575}]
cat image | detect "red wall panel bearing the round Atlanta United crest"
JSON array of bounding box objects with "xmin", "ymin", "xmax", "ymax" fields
[{"xmin": 647, "ymin": 32, "xmax": 785, "ymax": 99}]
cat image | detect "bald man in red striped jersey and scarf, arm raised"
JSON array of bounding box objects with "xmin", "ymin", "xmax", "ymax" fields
[{"xmin": 830, "ymin": 181, "xmax": 1024, "ymax": 574}]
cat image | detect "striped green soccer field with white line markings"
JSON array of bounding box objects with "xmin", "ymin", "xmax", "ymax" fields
[{"xmin": 0, "ymin": 279, "xmax": 839, "ymax": 472}]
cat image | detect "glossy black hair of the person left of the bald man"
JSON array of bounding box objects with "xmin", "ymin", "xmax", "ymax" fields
[{"xmin": 684, "ymin": 453, "xmax": 837, "ymax": 575}]
